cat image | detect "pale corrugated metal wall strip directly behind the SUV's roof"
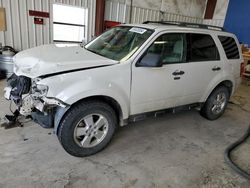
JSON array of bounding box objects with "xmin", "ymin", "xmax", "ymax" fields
[{"xmin": 105, "ymin": 1, "xmax": 224, "ymax": 26}]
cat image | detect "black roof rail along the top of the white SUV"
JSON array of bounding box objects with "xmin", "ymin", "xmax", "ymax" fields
[{"xmin": 143, "ymin": 21, "xmax": 225, "ymax": 31}]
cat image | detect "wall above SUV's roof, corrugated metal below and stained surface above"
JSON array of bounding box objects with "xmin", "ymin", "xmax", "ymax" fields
[{"xmin": 105, "ymin": 0, "xmax": 229, "ymax": 26}]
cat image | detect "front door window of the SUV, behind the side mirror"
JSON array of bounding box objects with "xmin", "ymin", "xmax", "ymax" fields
[{"xmin": 141, "ymin": 33, "xmax": 186, "ymax": 64}]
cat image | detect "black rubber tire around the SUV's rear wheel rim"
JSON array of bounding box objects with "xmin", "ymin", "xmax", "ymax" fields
[{"xmin": 200, "ymin": 86, "xmax": 229, "ymax": 120}]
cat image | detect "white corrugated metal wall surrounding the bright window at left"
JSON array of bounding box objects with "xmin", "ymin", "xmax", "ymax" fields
[{"xmin": 0, "ymin": 0, "xmax": 96, "ymax": 50}]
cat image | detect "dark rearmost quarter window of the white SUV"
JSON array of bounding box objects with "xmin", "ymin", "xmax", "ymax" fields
[{"xmin": 219, "ymin": 36, "xmax": 240, "ymax": 59}]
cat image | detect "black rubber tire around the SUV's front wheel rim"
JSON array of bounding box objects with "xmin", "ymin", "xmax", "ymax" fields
[{"xmin": 58, "ymin": 101, "xmax": 117, "ymax": 157}]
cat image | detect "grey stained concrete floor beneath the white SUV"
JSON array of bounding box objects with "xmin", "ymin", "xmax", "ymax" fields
[{"xmin": 0, "ymin": 81, "xmax": 250, "ymax": 188}]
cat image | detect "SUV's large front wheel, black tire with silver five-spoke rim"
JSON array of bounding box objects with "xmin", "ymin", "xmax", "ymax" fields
[{"xmin": 58, "ymin": 101, "xmax": 117, "ymax": 157}]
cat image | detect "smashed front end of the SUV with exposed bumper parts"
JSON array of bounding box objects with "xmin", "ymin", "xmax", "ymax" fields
[{"xmin": 4, "ymin": 74, "xmax": 68, "ymax": 128}]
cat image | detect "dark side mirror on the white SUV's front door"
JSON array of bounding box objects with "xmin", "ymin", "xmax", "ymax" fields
[{"xmin": 136, "ymin": 53, "xmax": 162, "ymax": 67}]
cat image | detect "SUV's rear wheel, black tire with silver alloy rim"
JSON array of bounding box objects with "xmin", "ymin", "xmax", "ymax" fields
[{"xmin": 201, "ymin": 86, "xmax": 229, "ymax": 120}]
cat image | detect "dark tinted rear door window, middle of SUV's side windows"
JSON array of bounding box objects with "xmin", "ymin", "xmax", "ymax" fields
[{"xmin": 187, "ymin": 33, "xmax": 220, "ymax": 61}]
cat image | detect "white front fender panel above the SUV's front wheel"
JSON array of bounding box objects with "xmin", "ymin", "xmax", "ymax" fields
[{"xmin": 39, "ymin": 66, "xmax": 130, "ymax": 122}]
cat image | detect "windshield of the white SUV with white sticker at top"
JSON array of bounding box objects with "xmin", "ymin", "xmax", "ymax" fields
[{"xmin": 85, "ymin": 26, "xmax": 153, "ymax": 61}]
